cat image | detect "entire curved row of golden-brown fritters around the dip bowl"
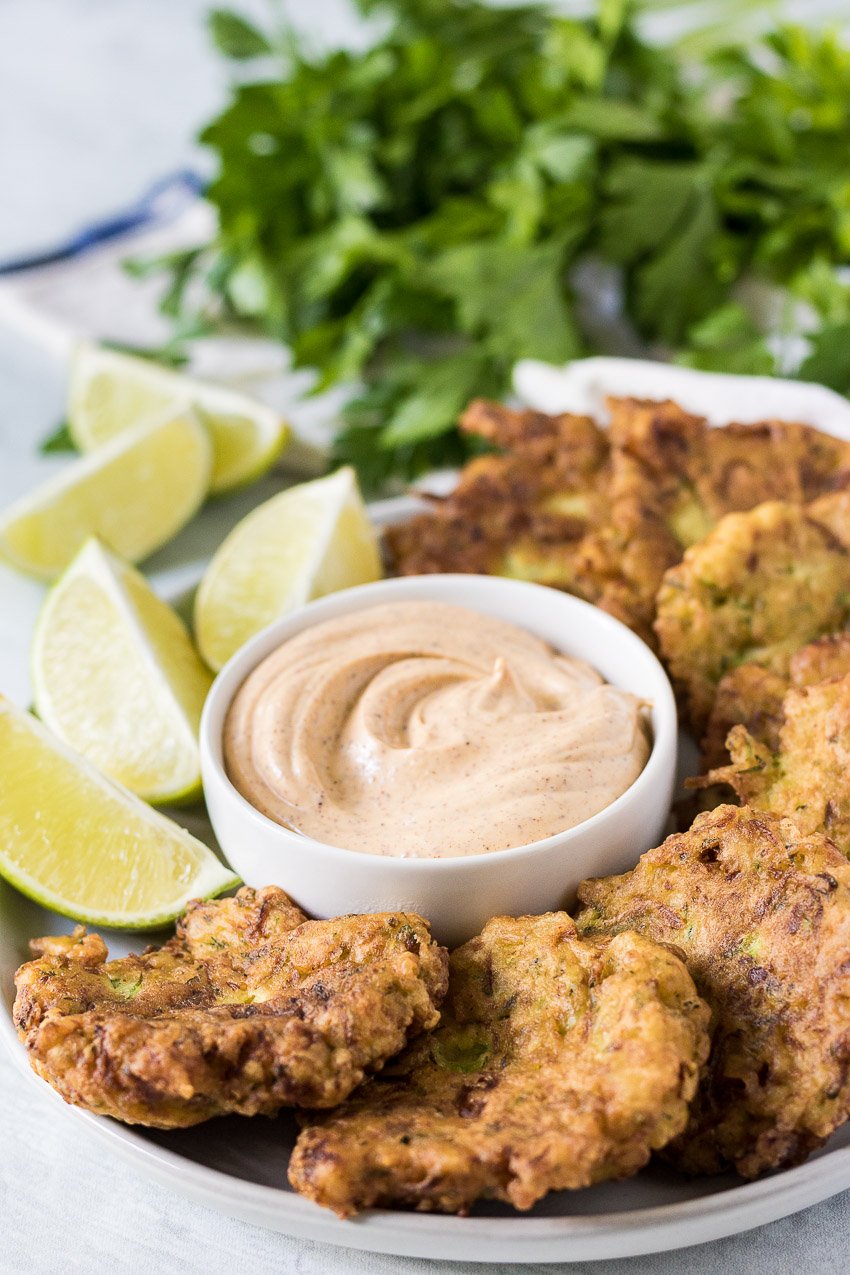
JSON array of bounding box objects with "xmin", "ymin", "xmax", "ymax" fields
[{"xmin": 15, "ymin": 399, "xmax": 850, "ymax": 1215}]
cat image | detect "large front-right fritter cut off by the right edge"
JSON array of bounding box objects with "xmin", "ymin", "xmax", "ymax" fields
[{"xmin": 577, "ymin": 806, "xmax": 850, "ymax": 1177}]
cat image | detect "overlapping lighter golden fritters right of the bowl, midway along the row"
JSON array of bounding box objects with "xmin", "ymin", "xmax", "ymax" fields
[{"xmin": 655, "ymin": 490, "xmax": 850, "ymax": 853}]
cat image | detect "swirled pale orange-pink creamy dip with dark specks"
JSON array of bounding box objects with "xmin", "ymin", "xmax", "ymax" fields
[{"xmin": 224, "ymin": 602, "xmax": 649, "ymax": 858}]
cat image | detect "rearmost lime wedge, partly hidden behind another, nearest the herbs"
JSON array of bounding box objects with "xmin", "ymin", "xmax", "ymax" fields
[{"xmin": 69, "ymin": 346, "xmax": 289, "ymax": 492}]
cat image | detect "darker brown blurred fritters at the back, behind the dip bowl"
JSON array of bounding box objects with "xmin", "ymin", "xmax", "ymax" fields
[{"xmin": 386, "ymin": 398, "xmax": 850, "ymax": 644}]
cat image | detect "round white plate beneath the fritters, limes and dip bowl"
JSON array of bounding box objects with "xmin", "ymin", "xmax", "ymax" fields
[{"xmin": 0, "ymin": 372, "xmax": 850, "ymax": 1265}]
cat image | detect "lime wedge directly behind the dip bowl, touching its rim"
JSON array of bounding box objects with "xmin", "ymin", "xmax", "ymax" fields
[{"xmin": 195, "ymin": 467, "xmax": 381, "ymax": 669}]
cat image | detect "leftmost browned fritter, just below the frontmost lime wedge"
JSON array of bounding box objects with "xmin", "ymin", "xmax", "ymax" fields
[{"xmin": 14, "ymin": 886, "xmax": 447, "ymax": 1128}]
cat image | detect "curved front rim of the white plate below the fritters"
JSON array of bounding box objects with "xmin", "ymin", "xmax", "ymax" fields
[{"xmin": 0, "ymin": 1006, "xmax": 850, "ymax": 1265}]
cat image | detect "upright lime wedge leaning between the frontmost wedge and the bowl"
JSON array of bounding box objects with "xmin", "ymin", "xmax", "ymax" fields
[{"xmin": 32, "ymin": 539, "xmax": 212, "ymax": 802}]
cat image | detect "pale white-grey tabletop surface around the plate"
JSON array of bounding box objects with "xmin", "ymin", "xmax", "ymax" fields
[{"xmin": 0, "ymin": 0, "xmax": 850, "ymax": 1275}]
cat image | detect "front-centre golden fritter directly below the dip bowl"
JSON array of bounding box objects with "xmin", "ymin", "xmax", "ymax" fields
[{"xmin": 289, "ymin": 913, "xmax": 709, "ymax": 1216}]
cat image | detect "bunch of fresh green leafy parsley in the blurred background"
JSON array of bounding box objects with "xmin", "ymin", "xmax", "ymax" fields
[{"xmin": 151, "ymin": 0, "xmax": 850, "ymax": 488}]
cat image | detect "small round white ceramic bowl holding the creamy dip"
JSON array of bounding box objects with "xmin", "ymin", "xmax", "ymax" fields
[{"xmin": 200, "ymin": 575, "xmax": 677, "ymax": 946}]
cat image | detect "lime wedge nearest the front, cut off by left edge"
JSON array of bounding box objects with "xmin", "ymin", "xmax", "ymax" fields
[{"xmin": 0, "ymin": 696, "xmax": 238, "ymax": 929}]
